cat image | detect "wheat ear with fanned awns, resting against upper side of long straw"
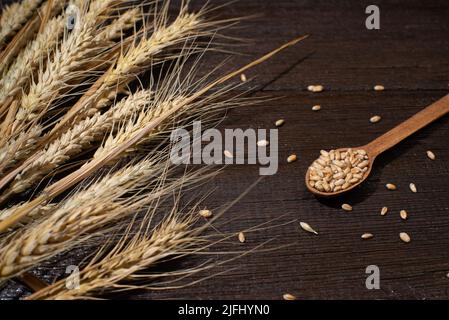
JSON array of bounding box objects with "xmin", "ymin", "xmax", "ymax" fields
[{"xmin": 93, "ymin": 50, "xmax": 257, "ymax": 161}]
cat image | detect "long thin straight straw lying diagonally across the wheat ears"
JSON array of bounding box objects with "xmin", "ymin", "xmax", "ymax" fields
[{"xmin": 0, "ymin": 36, "xmax": 307, "ymax": 232}]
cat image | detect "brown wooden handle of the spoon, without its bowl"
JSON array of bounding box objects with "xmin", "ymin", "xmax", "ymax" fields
[{"xmin": 365, "ymin": 94, "xmax": 449, "ymax": 157}]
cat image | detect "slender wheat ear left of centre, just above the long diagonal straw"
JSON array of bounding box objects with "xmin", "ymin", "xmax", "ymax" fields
[{"xmin": 0, "ymin": 90, "xmax": 151, "ymax": 202}]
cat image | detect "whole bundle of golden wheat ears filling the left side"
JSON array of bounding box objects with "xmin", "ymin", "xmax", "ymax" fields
[{"xmin": 0, "ymin": 0, "xmax": 304, "ymax": 299}]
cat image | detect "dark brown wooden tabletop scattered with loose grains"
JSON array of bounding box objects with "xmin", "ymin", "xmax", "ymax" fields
[{"xmin": 0, "ymin": 0, "xmax": 449, "ymax": 299}]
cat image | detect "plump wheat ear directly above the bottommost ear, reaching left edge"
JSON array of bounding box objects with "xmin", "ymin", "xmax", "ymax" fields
[{"xmin": 0, "ymin": 159, "xmax": 168, "ymax": 282}]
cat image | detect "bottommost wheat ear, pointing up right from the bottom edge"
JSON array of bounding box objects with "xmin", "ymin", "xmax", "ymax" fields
[{"xmin": 28, "ymin": 214, "xmax": 202, "ymax": 300}]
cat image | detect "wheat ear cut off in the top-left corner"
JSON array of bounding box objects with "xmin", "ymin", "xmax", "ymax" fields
[{"xmin": 0, "ymin": 0, "xmax": 42, "ymax": 49}]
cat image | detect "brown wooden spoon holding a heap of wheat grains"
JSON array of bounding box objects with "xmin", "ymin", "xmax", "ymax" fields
[{"xmin": 305, "ymin": 94, "xmax": 449, "ymax": 197}]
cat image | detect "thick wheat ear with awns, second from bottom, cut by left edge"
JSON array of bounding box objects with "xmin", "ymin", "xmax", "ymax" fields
[{"xmin": 0, "ymin": 154, "xmax": 207, "ymax": 283}]
